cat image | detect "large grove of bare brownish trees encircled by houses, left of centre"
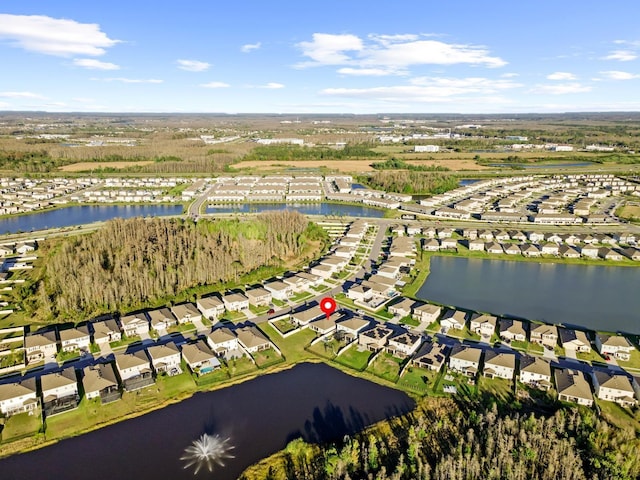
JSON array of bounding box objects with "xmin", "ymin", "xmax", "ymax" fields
[{"xmin": 32, "ymin": 211, "xmax": 324, "ymax": 319}]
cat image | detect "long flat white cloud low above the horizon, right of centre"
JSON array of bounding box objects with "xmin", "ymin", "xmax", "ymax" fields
[{"xmin": 320, "ymin": 77, "xmax": 522, "ymax": 103}]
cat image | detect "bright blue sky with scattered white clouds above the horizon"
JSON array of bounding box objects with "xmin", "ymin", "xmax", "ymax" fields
[{"xmin": 0, "ymin": 0, "xmax": 640, "ymax": 113}]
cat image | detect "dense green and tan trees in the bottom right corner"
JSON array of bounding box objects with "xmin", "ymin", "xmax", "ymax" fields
[{"xmin": 241, "ymin": 398, "xmax": 640, "ymax": 480}]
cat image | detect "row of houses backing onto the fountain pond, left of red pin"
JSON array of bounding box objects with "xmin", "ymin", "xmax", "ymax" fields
[{"xmin": 0, "ymin": 326, "xmax": 273, "ymax": 416}]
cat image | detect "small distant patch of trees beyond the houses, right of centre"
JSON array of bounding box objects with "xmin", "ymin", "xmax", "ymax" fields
[{"xmin": 357, "ymin": 170, "xmax": 458, "ymax": 194}]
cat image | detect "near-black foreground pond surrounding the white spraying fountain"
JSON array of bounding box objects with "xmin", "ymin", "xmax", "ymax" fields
[{"xmin": 0, "ymin": 364, "xmax": 415, "ymax": 480}]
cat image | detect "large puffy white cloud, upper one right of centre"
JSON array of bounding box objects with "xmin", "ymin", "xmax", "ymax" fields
[{"xmin": 296, "ymin": 33, "xmax": 507, "ymax": 71}]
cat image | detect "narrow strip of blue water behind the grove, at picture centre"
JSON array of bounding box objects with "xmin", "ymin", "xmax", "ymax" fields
[{"xmin": 207, "ymin": 203, "xmax": 384, "ymax": 218}]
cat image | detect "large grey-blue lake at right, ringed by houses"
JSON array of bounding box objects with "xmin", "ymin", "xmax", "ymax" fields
[{"xmin": 417, "ymin": 256, "xmax": 640, "ymax": 333}]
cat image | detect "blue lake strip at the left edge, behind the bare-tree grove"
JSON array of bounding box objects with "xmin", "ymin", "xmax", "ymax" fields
[{"xmin": 0, "ymin": 205, "xmax": 182, "ymax": 234}]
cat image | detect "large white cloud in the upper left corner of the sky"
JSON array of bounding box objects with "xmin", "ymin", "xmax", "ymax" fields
[{"xmin": 0, "ymin": 13, "xmax": 118, "ymax": 56}]
